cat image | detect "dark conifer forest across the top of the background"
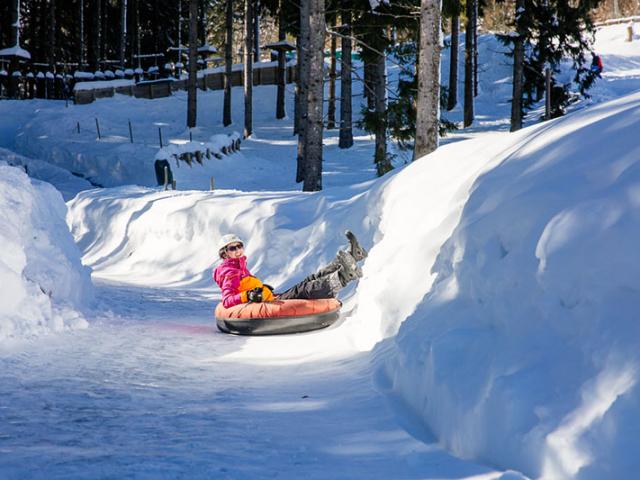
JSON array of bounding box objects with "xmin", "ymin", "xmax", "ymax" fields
[{"xmin": 0, "ymin": 0, "xmax": 638, "ymax": 190}]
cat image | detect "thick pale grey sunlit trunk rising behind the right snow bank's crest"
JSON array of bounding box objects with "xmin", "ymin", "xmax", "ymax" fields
[{"xmin": 413, "ymin": 0, "xmax": 441, "ymax": 160}]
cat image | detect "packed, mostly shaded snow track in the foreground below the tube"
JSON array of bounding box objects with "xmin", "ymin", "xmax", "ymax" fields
[{"xmin": 0, "ymin": 285, "xmax": 499, "ymax": 480}]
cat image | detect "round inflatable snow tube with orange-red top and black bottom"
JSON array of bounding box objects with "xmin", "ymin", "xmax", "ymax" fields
[{"xmin": 215, "ymin": 298, "xmax": 342, "ymax": 335}]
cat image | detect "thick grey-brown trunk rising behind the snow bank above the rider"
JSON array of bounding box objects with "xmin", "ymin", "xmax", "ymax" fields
[{"xmin": 303, "ymin": 0, "xmax": 326, "ymax": 192}]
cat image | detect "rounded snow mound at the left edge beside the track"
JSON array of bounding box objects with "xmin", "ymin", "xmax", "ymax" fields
[{"xmin": 0, "ymin": 162, "xmax": 92, "ymax": 341}]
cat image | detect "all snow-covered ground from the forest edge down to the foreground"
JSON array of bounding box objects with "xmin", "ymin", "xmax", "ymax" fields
[{"xmin": 0, "ymin": 26, "xmax": 640, "ymax": 480}]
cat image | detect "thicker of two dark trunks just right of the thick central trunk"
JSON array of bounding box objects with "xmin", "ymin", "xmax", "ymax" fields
[{"xmin": 338, "ymin": 4, "xmax": 353, "ymax": 148}]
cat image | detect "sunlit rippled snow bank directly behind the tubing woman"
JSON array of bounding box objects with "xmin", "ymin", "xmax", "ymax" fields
[{"xmin": 68, "ymin": 184, "xmax": 377, "ymax": 290}]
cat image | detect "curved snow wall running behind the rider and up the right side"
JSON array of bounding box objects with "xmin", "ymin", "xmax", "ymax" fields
[{"xmin": 63, "ymin": 85, "xmax": 640, "ymax": 479}]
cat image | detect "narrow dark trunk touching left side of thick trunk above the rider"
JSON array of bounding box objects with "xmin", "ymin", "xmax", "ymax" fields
[{"xmin": 296, "ymin": 0, "xmax": 313, "ymax": 182}]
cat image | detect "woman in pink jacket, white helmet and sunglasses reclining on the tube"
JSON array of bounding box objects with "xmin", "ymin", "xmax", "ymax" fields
[{"xmin": 213, "ymin": 230, "xmax": 367, "ymax": 308}]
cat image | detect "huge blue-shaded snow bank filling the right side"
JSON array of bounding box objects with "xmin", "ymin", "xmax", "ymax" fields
[{"xmin": 378, "ymin": 89, "xmax": 640, "ymax": 480}]
